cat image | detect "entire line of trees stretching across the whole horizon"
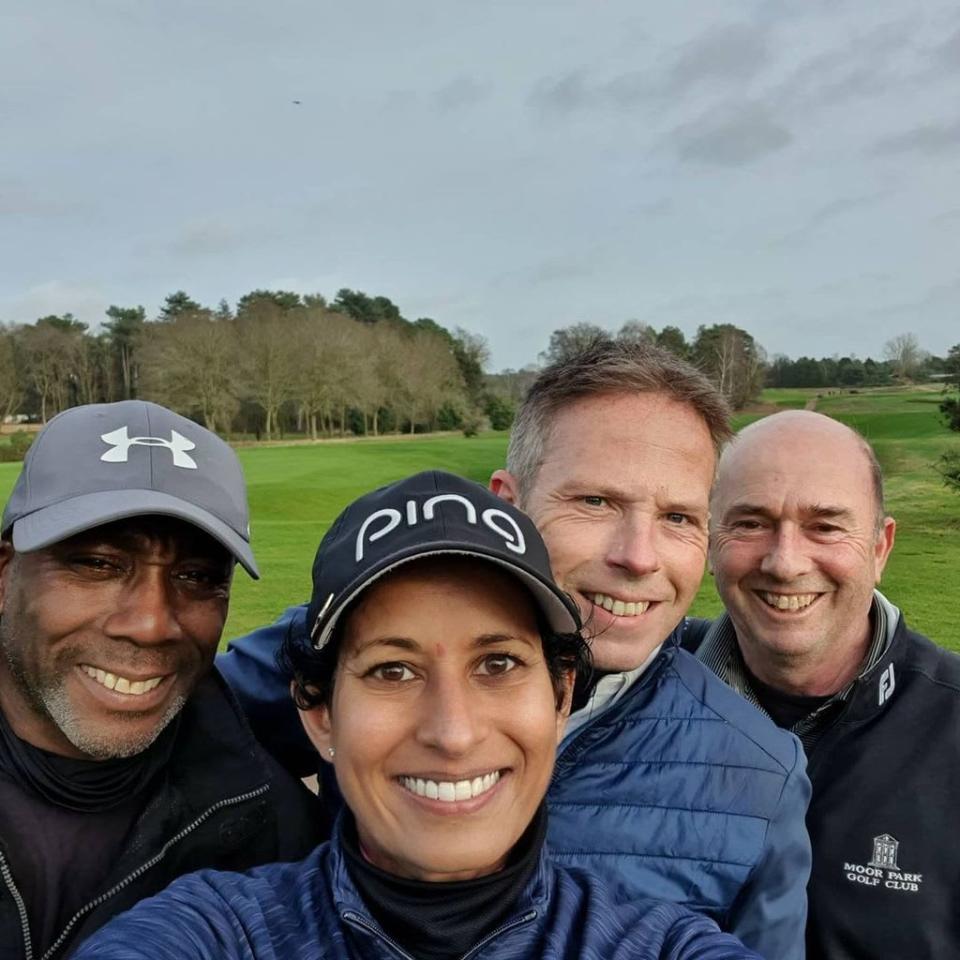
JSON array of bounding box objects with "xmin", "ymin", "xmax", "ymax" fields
[{"xmin": 0, "ymin": 288, "xmax": 960, "ymax": 440}]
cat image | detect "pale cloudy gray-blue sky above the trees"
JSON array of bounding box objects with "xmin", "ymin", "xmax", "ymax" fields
[{"xmin": 0, "ymin": 0, "xmax": 960, "ymax": 370}]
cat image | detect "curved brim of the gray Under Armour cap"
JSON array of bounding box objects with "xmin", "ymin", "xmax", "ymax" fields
[{"xmin": 13, "ymin": 490, "xmax": 260, "ymax": 580}]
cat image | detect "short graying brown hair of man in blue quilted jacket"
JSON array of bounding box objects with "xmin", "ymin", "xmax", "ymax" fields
[{"xmin": 507, "ymin": 337, "xmax": 731, "ymax": 498}]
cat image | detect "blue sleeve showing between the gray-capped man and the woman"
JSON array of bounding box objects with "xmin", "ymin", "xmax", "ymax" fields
[{"xmin": 217, "ymin": 604, "xmax": 317, "ymax": 777}]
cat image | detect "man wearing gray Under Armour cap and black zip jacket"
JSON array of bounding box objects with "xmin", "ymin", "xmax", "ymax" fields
[{"xmin": 0, "ymin": 401, "xmax": 323, "ymax": 960}]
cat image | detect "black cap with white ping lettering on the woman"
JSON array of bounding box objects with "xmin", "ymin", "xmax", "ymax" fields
[{"xmin": 307, "ymin": 470, "xmax": 580, "ymax": 650}]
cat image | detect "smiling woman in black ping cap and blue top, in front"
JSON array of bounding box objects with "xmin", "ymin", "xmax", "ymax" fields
[{"xmin": 77, "ymin": 472, "xmax": 756, "ymax": 960}]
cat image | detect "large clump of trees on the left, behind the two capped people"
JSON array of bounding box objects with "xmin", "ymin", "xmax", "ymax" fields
[{"xmin": 0, "ymin": 289, "xmax": 489, "ymax": 439}]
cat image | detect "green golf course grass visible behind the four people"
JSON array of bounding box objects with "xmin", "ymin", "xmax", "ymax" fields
[{"xmin": 0, "ymin": 389, "xmax": 960, "ymax": 650}]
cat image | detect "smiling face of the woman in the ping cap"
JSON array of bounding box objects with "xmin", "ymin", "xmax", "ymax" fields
[{"xmin": 305, "ymin": 557, "xmax": 565, "ymax": 880}]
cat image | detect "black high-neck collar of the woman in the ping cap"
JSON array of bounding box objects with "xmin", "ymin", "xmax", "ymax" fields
[{"xmin": 340, "ymin": 803, "xmax": 547, "ymax": 960}]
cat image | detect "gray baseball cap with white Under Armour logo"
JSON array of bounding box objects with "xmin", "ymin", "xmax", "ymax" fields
[{"xmin": 2, "ymin": 400, "xmax": 260, "ymax": 578}]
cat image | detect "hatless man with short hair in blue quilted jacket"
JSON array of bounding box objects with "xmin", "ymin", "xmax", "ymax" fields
[{"xmin": 218, "ymin": 340, "xmax": 810, "ymax": 960}]
